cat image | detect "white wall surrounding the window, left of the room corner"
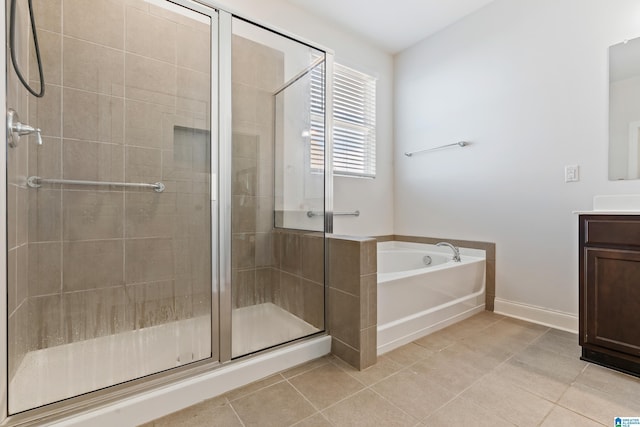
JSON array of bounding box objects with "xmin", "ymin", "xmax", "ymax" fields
[{"xmin": 212, "ymin": 0, "xmax": 394, "ymax": 236}]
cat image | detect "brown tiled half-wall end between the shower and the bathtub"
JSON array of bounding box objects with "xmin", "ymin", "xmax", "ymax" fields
[{"xmin": 327, "ymin": 236, "xmax": 377, "ymax": 369}]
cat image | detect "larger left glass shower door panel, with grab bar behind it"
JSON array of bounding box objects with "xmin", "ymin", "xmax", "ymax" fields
[{"xmin": 7, "ymin": 0, "xmax": 218, "ymax": 414}]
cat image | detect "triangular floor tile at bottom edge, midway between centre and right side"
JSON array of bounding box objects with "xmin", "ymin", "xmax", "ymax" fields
[{"xmin": 423, "ymin": 397, "xmax": 515, "ymax": 427}]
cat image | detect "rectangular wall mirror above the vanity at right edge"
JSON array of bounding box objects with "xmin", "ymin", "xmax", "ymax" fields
[{"xmin": 609, "ymin": 38, "xmax": 640, "ymax": 180}]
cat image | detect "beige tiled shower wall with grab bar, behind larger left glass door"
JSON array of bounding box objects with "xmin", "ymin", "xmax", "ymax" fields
[{"xmin": 8, "ymin": 0, "xmax": 211, "ymax": 378}]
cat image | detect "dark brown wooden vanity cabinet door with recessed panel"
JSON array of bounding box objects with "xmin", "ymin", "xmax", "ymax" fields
[{"xmin": 581, "ymin": 247, "xmax": 640, "ymax": 357}]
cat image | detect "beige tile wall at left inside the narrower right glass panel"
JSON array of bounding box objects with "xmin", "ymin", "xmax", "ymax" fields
[{"xmin": 231, "ymin": 35, "xmax": 284, "ymax": 308}]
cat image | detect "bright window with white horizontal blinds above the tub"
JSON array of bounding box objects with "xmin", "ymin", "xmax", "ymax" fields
[{"xmin": 310, "ymin": 64, "xmax": 376, "ymax": 178}]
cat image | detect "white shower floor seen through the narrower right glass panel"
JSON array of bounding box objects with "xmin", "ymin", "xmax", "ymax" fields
[{"xmin": 231, "ymin": 302, "xmax": 320, "ymax": 357}]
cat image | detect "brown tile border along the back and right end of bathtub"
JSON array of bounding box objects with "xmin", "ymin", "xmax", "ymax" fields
[{"xmin": 376, "ymin": 235, "xmax": 496, "ymax": 311}]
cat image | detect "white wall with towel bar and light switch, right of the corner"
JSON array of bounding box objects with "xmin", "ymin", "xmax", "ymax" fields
[{"xmin": 394, "ymin": 0, "xmax": 640, "ymax": 329}]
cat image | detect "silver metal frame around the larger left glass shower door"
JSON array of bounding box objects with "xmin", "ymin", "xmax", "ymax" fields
[{"xmin": 0, "ymin": 0, "xmax": 221, "ymax": 425}]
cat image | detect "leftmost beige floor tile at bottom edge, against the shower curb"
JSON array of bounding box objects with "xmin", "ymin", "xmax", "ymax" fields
[{"xmin": 150, "ymin": 399, "xmax": 242, "ymax": 427}]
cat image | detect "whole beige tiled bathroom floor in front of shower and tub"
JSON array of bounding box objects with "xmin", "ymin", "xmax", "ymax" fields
[{"xmin": 144, "ymin": 312, "xmax": 640, "ymax": 427}]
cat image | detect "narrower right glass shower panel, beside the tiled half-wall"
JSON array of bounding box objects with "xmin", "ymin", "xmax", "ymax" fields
[{"xmin": 231, "ymin": 19, "xmax": 325, "ymax": 357}]
